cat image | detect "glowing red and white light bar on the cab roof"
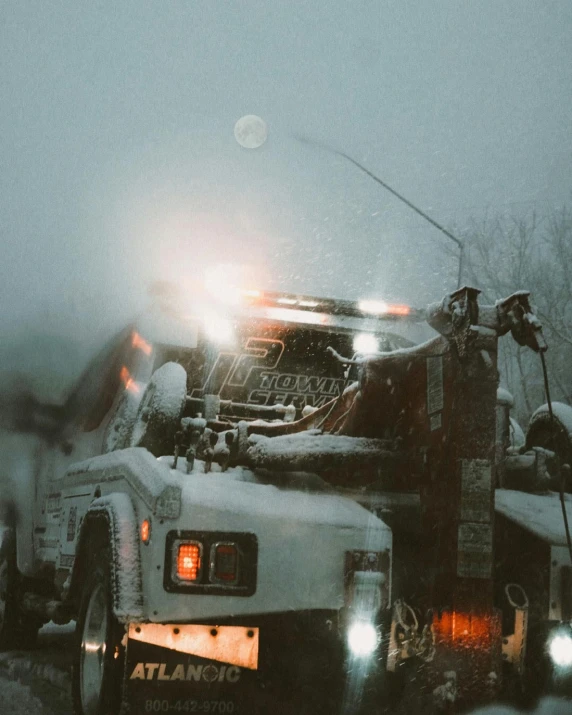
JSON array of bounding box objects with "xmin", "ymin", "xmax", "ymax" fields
[{"xmin": 242, "ymin": 290, "xmax": 424, "ymax": 323}]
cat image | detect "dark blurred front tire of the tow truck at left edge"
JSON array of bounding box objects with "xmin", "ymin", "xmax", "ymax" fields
[{"xmin": 0, "ymin": 532, "xmax": 42, "ymax": 650}]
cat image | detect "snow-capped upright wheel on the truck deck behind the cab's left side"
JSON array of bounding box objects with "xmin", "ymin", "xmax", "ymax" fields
[{"xmin": 131, "ymin": 362, "xmax": 187, "ymax": 457}]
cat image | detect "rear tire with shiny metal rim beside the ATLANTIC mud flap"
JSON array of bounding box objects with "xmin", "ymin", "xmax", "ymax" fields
[{"xmin": 72, "ymin": 542, "xmax": 125, "ymax": 715}]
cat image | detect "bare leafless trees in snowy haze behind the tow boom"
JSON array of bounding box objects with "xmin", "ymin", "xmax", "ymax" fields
[{"xmin": 464, "ymin": 207, "xmax": 572, "ymax": 422}]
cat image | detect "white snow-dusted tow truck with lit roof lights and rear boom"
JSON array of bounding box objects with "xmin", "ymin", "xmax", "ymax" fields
[{"xmin": 0, "ymin": 288, "xmax": 572, "ymax": 715}]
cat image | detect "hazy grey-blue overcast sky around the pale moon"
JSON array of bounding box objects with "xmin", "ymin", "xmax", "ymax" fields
[{"xmin": 0, "ymin": 0, "xmax": 572, "ymax": 364}]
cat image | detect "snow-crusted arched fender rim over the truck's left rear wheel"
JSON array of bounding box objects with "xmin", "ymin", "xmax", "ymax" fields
[{"xmin": 69, "ymin": 493, "xmax": 143, "ymax": 623}]
